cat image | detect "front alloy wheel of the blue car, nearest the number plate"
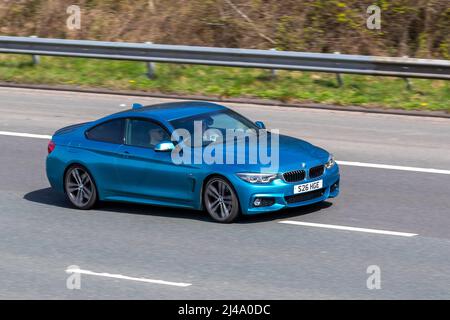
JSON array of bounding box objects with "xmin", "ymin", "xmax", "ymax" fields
[{"xmin": 203, "ymin": 177, "xmax": 239, "ymax": 223}]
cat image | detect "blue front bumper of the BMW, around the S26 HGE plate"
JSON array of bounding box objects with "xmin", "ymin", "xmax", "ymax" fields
[{"xmin": 232, "ymin": 164, "xmax": 340, "ymax": 214}]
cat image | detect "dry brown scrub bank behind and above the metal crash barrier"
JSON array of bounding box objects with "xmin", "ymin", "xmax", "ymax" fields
[{"xmin": 0, "ymin": 0, "xmax": 450, "ymax": 59}]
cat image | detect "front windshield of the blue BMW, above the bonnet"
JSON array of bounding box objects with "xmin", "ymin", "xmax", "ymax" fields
[{"xmin": 170, "ymin": 110, "xmax": 259, "ymax": 145}]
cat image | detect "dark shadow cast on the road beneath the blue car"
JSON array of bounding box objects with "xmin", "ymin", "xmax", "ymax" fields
[{"xmin": 23, "ymin": 188, "xmax": 332, "ymax": 224}]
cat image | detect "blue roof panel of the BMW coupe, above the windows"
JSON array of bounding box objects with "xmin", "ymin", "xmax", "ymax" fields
[{"xmin": 112, "ymin": 101, "xmax": 228, "ymax": 121}]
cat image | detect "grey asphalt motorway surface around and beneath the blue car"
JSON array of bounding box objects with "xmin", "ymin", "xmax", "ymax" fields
[{"xmin": 0, "ymin": 88, "xmax": 450, "ymax": 299}]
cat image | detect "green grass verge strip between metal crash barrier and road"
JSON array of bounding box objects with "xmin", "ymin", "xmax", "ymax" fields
[{"xmin": 0, "ymin": 54, "xmax": 450, "ymax": 111}]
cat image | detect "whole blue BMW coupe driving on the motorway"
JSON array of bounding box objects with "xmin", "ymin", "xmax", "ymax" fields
[{"xmin": 46, "ymin": 101, "xmax": 339, "ymax": 222}]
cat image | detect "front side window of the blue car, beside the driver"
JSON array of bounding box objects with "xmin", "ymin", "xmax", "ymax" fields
[{"xmin": 127, "ymin": 119, "xmax": 170, "ymax": 148}]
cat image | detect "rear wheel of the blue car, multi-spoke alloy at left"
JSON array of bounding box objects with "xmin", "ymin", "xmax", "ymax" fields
[{"xmin": 64, "ymin": 165, "xmax": 97, "ymax": 210}]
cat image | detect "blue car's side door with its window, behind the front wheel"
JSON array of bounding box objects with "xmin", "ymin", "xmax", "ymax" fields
[{"xmin": 116, "ymin": 118, "xmax": 195, "ymax": 204}]
